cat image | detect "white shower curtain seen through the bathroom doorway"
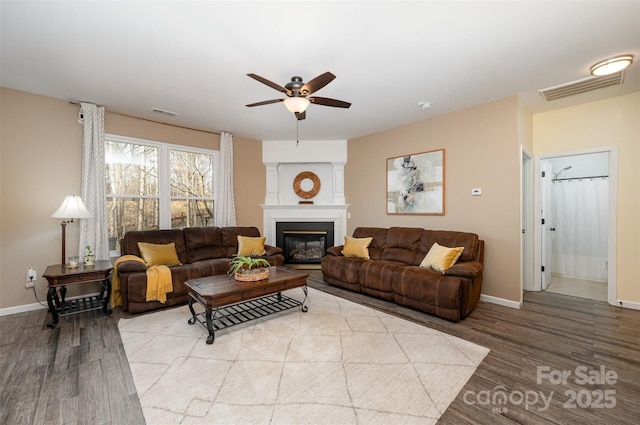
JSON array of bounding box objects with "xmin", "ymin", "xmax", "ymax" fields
[{"xmin": 551, "ymin": 178, "xmax": 609, "ymax": 281}]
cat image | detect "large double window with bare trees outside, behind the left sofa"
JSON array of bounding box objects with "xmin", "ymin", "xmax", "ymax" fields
[{"xmin": 105, "ymin": 135, "xmax": 218, "ymax": 255}]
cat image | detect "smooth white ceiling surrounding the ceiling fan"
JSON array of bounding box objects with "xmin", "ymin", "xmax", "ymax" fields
[{"xmin": 0, "ymin": 0, "xmax": 640, "ymax": 140}]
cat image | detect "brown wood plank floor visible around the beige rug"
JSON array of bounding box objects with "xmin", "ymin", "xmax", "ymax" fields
[{"xmin": 0, "ymin": 271, "xmax": 640, "ymax": 425}]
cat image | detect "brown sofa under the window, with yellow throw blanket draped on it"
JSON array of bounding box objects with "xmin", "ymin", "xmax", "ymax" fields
[{"xmin": 118, "ymin": 227, "xmax": 284, "ymax": 313}]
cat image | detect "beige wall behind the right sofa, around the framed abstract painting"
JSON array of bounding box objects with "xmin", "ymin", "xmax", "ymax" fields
[{"xmin": 345, "ymin": 97, "xmax": 530, "ymax": 303}]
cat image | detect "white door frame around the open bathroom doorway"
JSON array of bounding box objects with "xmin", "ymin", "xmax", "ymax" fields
[{"xmin": 532, "ymin": 146, "xmax": 618, "ymax": 305}]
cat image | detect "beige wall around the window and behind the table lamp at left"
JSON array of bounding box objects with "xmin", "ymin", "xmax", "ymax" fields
[{"xmin": 0, "ymin": 88, "xmax": 265, "ymax": 308}]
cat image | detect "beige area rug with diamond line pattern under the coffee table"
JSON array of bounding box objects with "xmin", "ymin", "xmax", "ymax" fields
[{"xmin": 118, "ymin": 288, "xmax": 489, "ymax": 425}]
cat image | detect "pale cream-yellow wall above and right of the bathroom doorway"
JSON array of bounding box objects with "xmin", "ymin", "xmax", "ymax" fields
[{"xmin": 533, "ymin": 93, "xmax": 640, "ymax": 303}]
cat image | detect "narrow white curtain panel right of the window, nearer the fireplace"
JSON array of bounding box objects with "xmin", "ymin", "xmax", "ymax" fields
[{"xmin": 214, "ymin": 132, "xmax": 236, "ymax": 227}]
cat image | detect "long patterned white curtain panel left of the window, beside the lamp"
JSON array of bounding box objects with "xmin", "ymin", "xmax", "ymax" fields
[{"xmin": 79, "ymin": 102, "xmax": 109, "ymax": 260}]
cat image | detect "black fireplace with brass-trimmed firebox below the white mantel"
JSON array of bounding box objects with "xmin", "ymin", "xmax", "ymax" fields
[{"xmin": 276, "ymin": 222, "xmax": 333, "ymax": 269}]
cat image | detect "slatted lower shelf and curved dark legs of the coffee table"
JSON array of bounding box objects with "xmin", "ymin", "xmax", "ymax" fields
[{"xmin": 188, "ymin": 286, "xmax": 308, "ymax": 344}]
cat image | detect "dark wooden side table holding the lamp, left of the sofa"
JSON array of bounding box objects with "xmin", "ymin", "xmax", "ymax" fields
[{"xmin": 42, "ymin": 261, "xmax": 113, "ymax": 329}]
